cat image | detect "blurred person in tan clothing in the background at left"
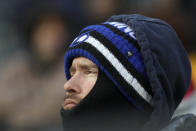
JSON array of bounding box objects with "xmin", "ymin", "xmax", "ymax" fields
[{"xmin": 0, "ymin": 0, "xmax": 83, "ymax": 131}]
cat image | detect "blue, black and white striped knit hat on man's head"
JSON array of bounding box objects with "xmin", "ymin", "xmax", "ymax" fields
[{"xmin": 65, "ymin": 22, "xmax": 152, "ymax": 110}]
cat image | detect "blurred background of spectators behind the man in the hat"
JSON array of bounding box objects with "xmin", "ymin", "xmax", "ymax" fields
[{"xmin": 0, "ymin": 0, "xmax": 196, "ymax": 131}]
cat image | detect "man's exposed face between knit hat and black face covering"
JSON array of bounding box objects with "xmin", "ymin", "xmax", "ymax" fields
[{"xmin": 64, "ymin": 57, "xmax": 98, "ymax": 110}]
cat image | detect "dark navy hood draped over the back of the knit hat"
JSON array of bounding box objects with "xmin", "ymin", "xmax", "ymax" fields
[{"xmin": 108, "ymin": 14, "xmax": 191, "ymax": 131}]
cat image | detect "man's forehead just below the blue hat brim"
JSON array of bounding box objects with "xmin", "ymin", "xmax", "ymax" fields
[{"xmin": 72, "ymin": 57, "xmax": 97, "ymax": 68}]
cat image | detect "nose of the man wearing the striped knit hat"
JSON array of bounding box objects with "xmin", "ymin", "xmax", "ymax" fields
[{"xmin": 64, "ymin": 76, "xmax": 81, "ymax": 94}]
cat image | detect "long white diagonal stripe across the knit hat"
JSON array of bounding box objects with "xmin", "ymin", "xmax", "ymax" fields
[{"xmin": 77, "ymin": 35, "xmax": 152, "ymax": 104}]
